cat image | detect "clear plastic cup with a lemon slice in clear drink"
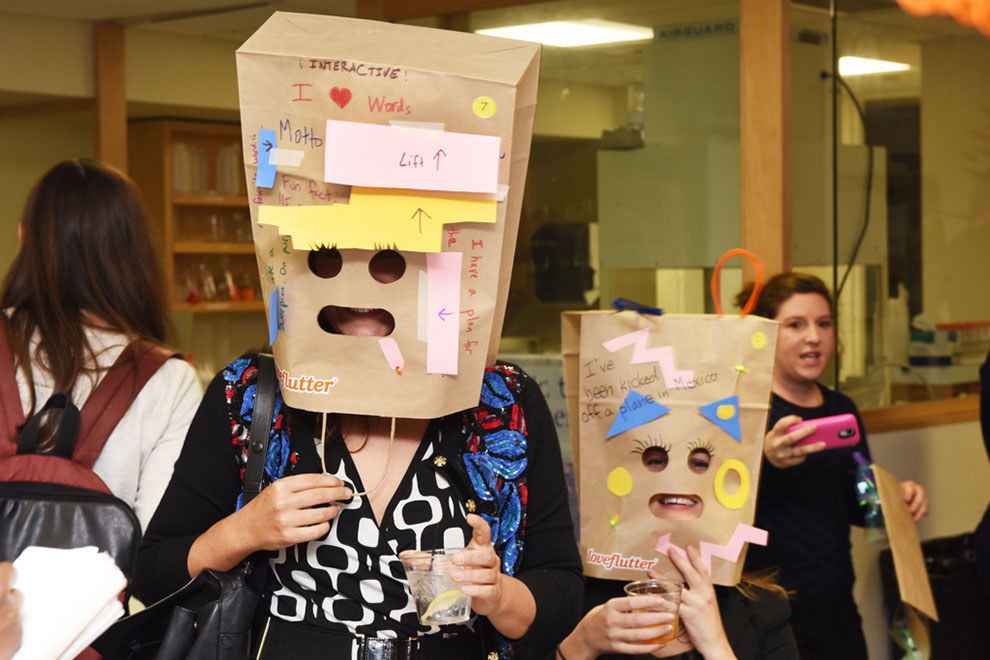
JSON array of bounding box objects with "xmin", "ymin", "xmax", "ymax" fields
[{"xmin": 400, "ymin": 548, "xmax": 471, "ymax": 626}]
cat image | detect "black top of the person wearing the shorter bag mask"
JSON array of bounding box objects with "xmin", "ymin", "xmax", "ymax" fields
[{"xmin": 585, "ymin": 578, "xmax": 798, "ymax": 660}]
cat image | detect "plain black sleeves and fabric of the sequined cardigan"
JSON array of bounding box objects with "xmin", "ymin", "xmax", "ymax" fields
[{"xmin": 134, "ymin": 358, "xmax": 583, "ymax": 647}]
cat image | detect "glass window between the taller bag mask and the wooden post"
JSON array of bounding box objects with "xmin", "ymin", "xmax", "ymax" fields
[{"xmin": 432, "ymin": 0, "xmax": 740, "ymax": 355}]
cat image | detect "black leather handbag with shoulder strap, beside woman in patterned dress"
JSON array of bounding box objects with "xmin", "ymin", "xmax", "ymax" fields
[{"xmin": 93, "ymin": 355, "xmax": 276, "ymax": 660}]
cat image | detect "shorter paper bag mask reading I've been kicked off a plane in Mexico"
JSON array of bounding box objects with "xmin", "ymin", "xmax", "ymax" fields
[{"xmin": 563, "ymin": 250, "xmax": 777, "ymax": 585}]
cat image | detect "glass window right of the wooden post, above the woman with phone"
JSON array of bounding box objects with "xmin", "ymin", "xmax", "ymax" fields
[{"xmin": 808, "ymin": 1, "xmax": 990, "ymax": 408}]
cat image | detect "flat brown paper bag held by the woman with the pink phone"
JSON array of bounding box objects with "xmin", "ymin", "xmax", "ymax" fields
[{"xmin": 870, "ymin": 465, "xmax": 938, "ymax": 621}]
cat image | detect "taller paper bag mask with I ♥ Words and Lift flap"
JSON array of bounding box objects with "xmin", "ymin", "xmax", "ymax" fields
[{"xmin": 237, "ymin": 12, "xmax": 540, "ymax": 418}]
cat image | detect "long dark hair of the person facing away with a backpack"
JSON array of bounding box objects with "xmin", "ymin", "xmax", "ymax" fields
[{"xmin": 0, "ymin": 159, "xmax": 168, "ymax": 446}]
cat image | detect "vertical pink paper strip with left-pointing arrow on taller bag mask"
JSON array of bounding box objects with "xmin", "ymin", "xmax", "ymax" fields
[{"xmin": 426, "ymin": 252, "xmax": 461, "ymax": 374}]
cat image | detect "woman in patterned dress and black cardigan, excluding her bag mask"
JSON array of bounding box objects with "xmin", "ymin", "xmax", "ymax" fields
[{"xmin": 131, "ymin": 241, "xmax": 581, "ymax": 657}]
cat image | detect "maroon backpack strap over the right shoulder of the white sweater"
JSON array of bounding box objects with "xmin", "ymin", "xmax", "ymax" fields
[{"xmin": 72, "ymin": 339, "xmax": 181, "ymax": 469}]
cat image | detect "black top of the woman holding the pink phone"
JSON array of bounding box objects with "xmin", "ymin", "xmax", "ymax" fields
[{"xmin": 746, "ymin": 385, "xmax": 871, "ymax": 598}]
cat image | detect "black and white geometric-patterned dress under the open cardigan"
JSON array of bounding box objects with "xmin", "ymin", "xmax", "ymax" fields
[{"xmin": 270, "ymin": 425, "xmax": 471, "ymax": 637}]
